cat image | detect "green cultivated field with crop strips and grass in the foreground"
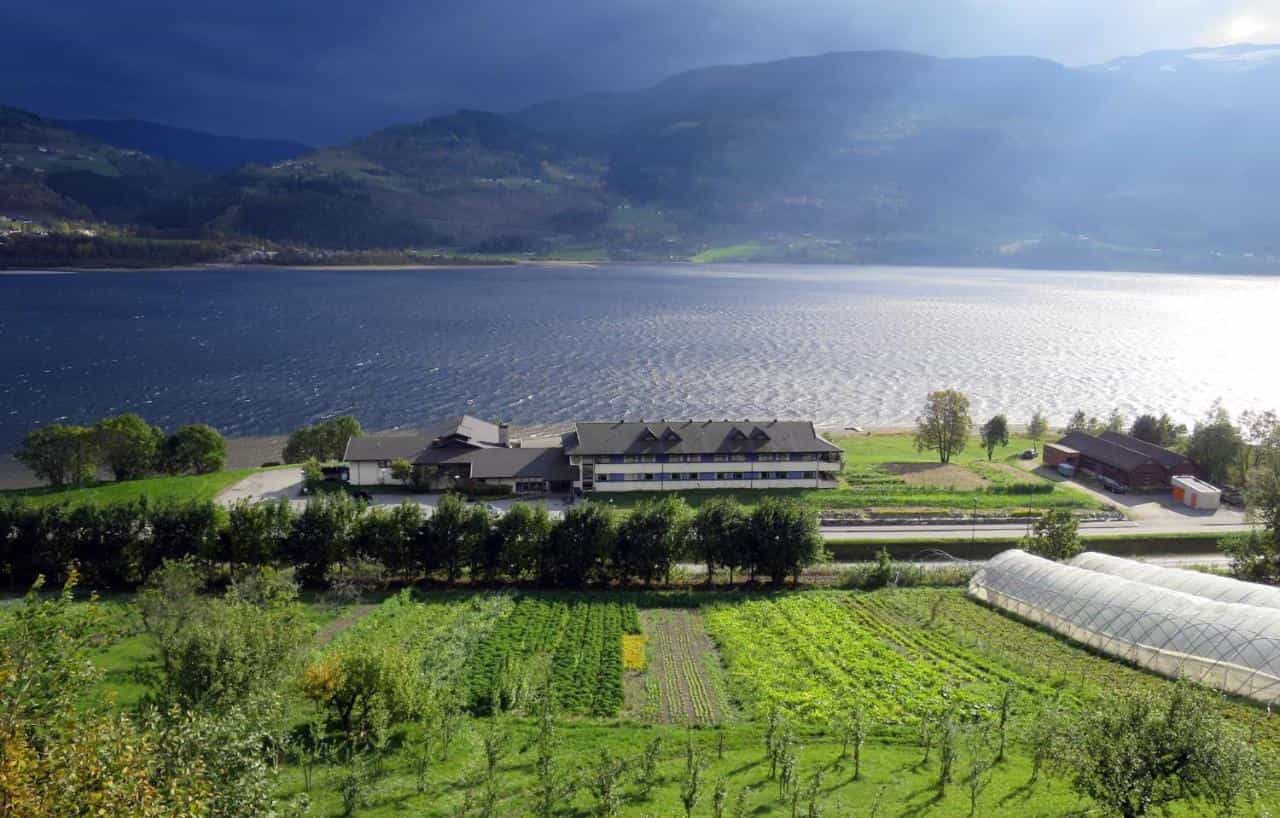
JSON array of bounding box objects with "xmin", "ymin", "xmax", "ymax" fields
[{"xmin": 67, "ymin": 589, "xmax": 1280, "ymax": 818}]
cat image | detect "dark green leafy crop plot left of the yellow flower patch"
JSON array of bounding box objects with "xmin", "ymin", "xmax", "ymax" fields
[{"xmin": 467, "ymin": 597, "xmax": 639, "ymax": 716}]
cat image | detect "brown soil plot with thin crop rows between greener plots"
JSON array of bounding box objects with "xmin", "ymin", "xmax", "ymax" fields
[{"xmin": 626, "ymin": 608, "xmax": 731, "ymax": 725}]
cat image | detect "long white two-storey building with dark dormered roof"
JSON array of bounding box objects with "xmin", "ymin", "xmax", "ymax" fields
[{"xmin": 564, "ymin": 420, "xmax": 841, "ymax": 493}]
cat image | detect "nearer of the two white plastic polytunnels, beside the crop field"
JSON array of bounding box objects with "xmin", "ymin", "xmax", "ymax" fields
[{"xmin": 969, "ymin": 549, "xmax": 1280, "ymax": 704}]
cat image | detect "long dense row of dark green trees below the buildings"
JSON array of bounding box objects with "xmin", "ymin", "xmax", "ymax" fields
[{"xmin": 0, "ymin": 494, "xmax": 823, "ymax": 588}]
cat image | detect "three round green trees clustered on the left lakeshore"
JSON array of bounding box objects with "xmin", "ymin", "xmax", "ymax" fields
[{"xmin": 14, "ymin": 413, "xmax": 227, "ymax": 486}]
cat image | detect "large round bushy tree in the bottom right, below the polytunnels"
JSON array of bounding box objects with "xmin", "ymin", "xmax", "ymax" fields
[{"xmin": 1050, "ymin": 684, "xmax": 1262, "ymax": 818}]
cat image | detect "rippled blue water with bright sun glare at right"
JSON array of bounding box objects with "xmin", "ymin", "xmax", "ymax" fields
[{"xmin": 0, "ymin": 264, "xmax": 1280, "ymax": 451}]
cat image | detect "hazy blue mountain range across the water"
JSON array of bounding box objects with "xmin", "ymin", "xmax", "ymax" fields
[{"xmin": 0, "ymin": 46, "xmax": 1280, "ymax": 269}]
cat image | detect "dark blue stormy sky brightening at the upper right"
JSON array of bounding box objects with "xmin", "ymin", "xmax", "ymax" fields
[{"xmin": 0, "ymin": 0, "xmax": 1280, "ymax": 145}]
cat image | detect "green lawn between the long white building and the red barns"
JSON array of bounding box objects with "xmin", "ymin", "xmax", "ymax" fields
[{"xmin": 593, "ymin": 433, "xmax": 1102, "ymax": 516}]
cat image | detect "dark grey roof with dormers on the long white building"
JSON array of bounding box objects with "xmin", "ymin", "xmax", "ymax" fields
[{"xmin": 564, "ymin": 420, "xmax": 840, "ymax": 454}]
